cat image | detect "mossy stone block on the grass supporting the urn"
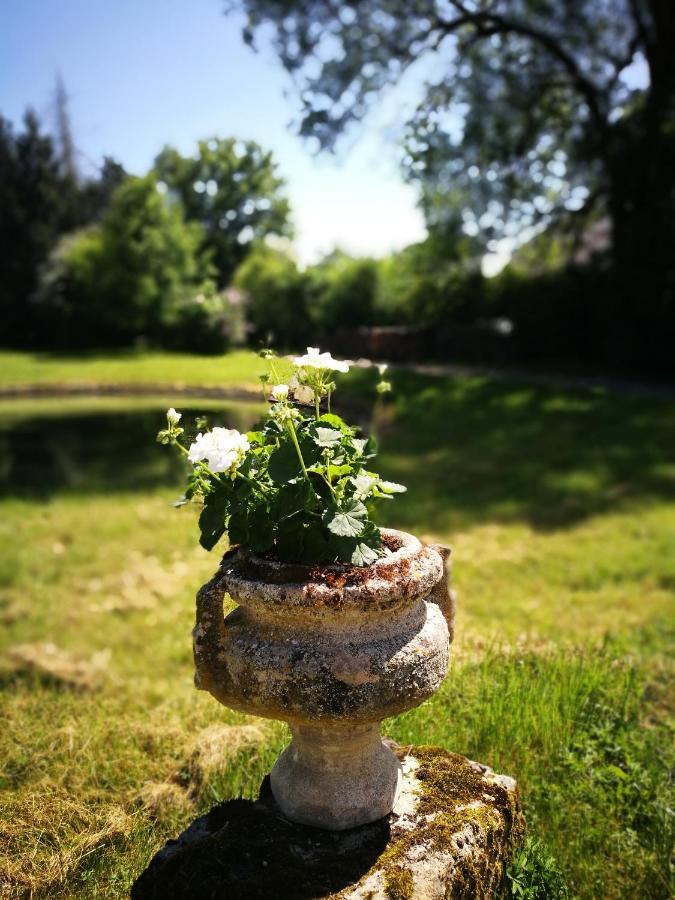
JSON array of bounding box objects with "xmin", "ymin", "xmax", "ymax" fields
[{"xmin": 132, "ymin": 747, "xmax": 523, "ymax": 900}]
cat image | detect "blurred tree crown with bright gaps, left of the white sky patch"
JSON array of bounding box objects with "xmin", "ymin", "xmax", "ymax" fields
[{"xmin": 155, "ymin": 138, "xmax": 291, "ymax": 286}]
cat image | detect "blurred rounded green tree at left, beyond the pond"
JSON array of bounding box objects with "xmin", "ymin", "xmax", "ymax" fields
[{"xmin": 38, "ymin": 176, "xmax": 214, "ymax": 347}]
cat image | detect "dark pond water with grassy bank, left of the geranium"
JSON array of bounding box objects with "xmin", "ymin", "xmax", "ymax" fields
[{"xmin": 0, "ymin": 397, "xmax": 263, "ymax": 498}]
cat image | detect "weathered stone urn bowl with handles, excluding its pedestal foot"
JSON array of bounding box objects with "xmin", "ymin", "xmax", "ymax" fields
[{"xmin": 194, "ymin": 529, "xmax": 449, "ymax": 725}]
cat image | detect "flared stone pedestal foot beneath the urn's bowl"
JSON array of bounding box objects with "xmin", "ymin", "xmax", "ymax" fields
[{"xmin": 270, "ymin": 725, "xmax": 402, "ymax": 831}]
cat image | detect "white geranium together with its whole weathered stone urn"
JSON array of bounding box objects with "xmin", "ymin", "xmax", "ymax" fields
[{"xmin": 158, "ymin": 348, "xmax": 453, "ymax": 829}]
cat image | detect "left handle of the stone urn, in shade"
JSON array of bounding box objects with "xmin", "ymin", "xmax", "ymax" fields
[{"xmin": 192, "ymin": 553, "xmax": 238, "ymax": 705}]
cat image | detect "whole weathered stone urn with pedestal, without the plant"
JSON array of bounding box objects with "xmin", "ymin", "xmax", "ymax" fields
[{"xmin": 194, "ymin": 530, "xmax": 454, "ymax": 830}]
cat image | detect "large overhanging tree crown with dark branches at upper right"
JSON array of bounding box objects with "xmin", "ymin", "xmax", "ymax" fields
[{"xmin": 230, "ymin": 0, "xmax": 675, "ymax": 275}]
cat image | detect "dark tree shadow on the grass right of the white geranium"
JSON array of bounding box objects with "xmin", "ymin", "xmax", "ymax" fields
[{"xmin": 378, "ymin": 374, "xmax": 675, "ymax": 531}]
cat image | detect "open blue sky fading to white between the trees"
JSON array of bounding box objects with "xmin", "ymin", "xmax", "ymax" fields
[{"xmin": 0, "ymin": 0, "xmax": 424, "ymax": 262}]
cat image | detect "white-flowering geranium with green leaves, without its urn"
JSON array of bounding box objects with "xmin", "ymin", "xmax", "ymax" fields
[{"xmin": 162, "ymin": 351, "xmax": 405, "ymax": 566}]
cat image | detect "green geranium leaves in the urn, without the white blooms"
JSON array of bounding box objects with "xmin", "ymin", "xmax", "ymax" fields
[{"xmin": 186, "ymin": 415, "xmax": 402, "ymax": 565}]
